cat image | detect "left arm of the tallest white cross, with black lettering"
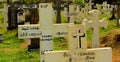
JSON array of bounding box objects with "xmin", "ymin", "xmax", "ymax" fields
[{"xmin": 18, "ymin": 24, "xmax": 42, "ymax": 39}]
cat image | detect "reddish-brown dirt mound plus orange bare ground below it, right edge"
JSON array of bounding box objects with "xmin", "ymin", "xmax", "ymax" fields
[{"xmin": 100, "ymin": 29, "xmax": 120, "ymax": 62}]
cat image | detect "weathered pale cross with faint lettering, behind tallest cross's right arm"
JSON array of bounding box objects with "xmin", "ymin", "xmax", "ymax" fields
[{"xmin": 64, "ymin": 5, "xmax": 88, "ymax": 23}]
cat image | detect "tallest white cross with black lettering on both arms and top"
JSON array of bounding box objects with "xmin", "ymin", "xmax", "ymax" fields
[{"xmin": 18, "ymin": 3, "xmax": 74, "ymax": 62}]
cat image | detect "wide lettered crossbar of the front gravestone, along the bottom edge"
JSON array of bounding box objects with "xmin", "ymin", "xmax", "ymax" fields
[{"xmin": 45, "ymin": 48, "xmax": 112, "ymax": 62}]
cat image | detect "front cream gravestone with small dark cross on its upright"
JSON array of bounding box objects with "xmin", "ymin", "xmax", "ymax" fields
[{"xmin": 44, "ymin": 24, "xmax": 112, "ymax": 62}]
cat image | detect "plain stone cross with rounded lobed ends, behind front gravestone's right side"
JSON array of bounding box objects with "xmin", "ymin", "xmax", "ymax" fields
[{"xmin": 84, "ymin": 10, "xmax": 108, "ymax": 48}]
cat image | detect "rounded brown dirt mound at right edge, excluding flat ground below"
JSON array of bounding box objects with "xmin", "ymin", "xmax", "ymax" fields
[{"xmin": 100, "ymin": 29, "xmax": 120, "ymax": 47}]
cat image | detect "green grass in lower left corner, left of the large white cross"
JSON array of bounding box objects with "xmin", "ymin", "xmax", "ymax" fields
[{"xmin": 0, "ymin": 29, "xmax": 40, "ymax": 62}]
